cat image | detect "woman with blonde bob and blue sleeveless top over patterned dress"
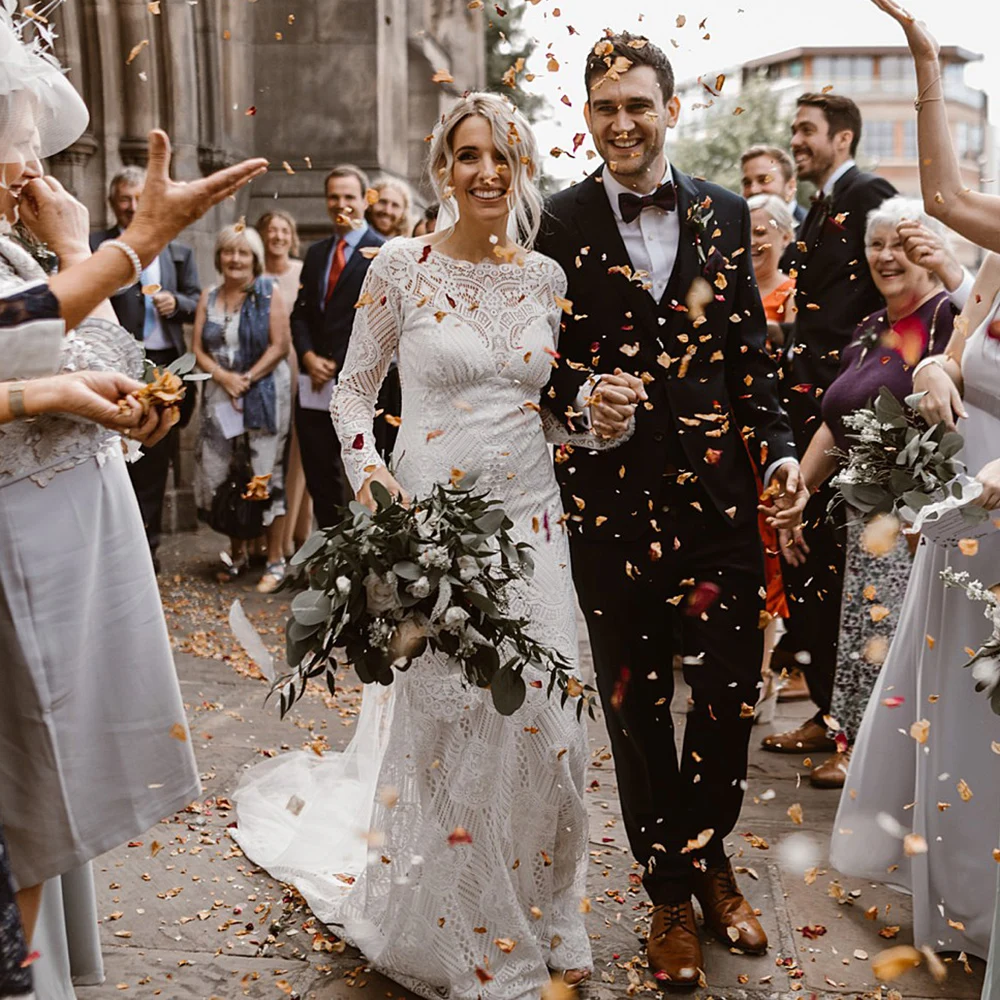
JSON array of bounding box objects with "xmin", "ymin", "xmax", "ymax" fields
[{"xmin": 194, "ymin": 226, "xmax": 292, "ymax": 589}]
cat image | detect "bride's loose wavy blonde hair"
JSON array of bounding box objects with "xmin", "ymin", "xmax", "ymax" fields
[{"xmin": 428, "ymin": 91, "xmax": 542, "ymax": 250}]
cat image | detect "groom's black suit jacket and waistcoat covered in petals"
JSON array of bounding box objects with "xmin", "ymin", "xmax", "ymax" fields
[{"xmin": 536, "ymin": 169, "xmax": 795, "ymax": 541}]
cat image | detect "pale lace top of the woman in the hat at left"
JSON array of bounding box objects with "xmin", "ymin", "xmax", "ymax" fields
[{"xmin": 0, "ymin": 237, "xmax": 143, "ymax": 487}]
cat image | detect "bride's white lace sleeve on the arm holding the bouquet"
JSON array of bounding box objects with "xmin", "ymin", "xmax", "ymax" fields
[{"xmin": 330, "ymin": 247, "xmax": 402, "ymax": 493}]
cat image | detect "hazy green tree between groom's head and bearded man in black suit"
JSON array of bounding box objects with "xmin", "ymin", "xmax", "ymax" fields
[{"xmin": 670, "ymin": 76, "xmax": 789, "ymax": 193}]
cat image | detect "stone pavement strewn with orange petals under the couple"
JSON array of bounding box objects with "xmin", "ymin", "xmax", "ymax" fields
[{"xmin": 76, "ymin": 530, "xmax": 992, "ymax": 1000}]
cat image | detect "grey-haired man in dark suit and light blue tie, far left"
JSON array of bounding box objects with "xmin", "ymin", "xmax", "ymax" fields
[{"xmin": 90, "ymin": 166, "xmax": 201, "ymax": 572}]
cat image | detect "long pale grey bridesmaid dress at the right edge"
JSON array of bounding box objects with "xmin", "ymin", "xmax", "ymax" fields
[{"xmin": 830, "ymin": 295, "xmax": 1000, "ymax": 958}]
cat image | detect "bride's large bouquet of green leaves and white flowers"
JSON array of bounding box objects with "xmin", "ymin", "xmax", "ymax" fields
[{"xmin": 273, "ymin": 477, "xmax": 590, "ymax": 718}]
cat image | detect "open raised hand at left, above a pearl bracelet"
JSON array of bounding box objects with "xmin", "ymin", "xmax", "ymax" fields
[{"xmin": 124, "ymin": 129, "xmax": 267, "ymax": 264}]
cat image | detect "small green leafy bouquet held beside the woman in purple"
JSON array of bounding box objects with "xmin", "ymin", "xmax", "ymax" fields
[{"xmin": 833, "ymin": 386, "xmax": 986, "ymax": 520}]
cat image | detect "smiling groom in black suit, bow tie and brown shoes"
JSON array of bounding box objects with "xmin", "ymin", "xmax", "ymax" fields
[{"xmin": 537, "ymin": 33, "xmax": 807, "ymax": 988}]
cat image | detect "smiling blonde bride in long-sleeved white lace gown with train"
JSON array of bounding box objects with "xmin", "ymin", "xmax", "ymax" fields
[{"xmin": 234, "ymin": 94, "xmax": 638, "ymax": 1000}]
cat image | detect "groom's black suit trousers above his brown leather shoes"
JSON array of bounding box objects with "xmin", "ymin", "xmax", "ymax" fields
[{"xmin": 572, "ymin": 484, "xmax": 764, "ymax": 904}]
